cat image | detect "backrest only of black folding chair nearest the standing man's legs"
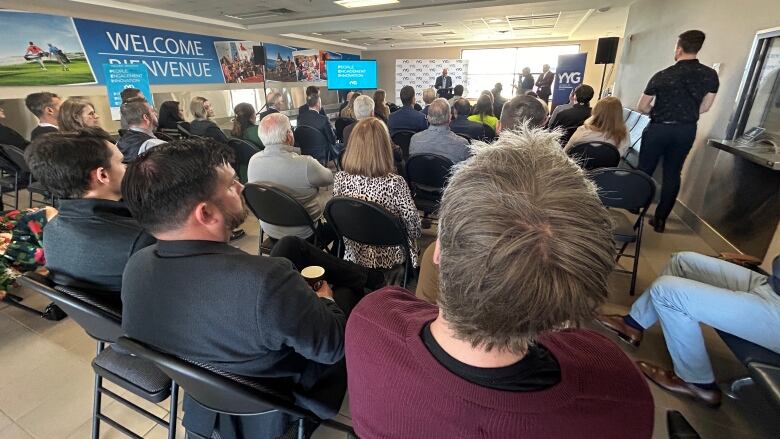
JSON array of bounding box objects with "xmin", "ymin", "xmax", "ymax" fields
[{"xmin": 590, "ymin": 168, "xmax": 655, "ymax": 214}]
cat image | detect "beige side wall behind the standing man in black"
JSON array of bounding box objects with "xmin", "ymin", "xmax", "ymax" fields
[{"xmin": 615, "ymin": 0, "xmax": 780, "ymax": 262}]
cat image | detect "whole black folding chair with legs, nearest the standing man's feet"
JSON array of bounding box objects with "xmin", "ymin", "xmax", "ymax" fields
[{"xmin": 591, "ymin": 168, "xmax": 655, "ymax": 296}]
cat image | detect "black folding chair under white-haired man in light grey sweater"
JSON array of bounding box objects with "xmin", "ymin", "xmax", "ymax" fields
[{"xmin": 243, "ymin": 181, "xmax": 322, "ymax": 255}]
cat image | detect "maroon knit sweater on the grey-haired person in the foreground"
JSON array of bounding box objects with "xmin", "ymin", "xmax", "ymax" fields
[{"xmin": 346, "ymin": 287, "xmax": 654, "ymax": 439}]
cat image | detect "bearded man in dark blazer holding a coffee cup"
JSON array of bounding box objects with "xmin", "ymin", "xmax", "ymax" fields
[{"xmin": 122, "ymin": 138, "xmax": 372, "ymax": 438}]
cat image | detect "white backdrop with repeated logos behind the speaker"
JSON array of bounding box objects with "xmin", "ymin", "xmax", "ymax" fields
[{"xmin": 395, "ymin": 59, "xmax": 468, "ymax": 105}]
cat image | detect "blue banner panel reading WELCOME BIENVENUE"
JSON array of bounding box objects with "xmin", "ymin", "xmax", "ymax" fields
[{"xmin": 73, "ymin": 18, "xmax": 225, "ymax": 84}]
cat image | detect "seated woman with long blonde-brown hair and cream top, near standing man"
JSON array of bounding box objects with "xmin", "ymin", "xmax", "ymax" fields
[{"xmin": 564, "ymin": 96, "xmax": 629, "ymax": 156}]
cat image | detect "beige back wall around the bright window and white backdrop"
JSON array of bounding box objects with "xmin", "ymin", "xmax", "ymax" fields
[{"xmin": 363, "ymin": 40, "xmax": 620, "ymax": 104}]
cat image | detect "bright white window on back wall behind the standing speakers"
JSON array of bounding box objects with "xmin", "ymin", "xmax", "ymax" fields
[{"xmin": 456, "ymin": 44, "xmax": 580, "ymax": 99}]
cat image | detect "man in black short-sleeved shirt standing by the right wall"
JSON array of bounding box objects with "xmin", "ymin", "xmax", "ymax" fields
[{"xmin": 637, "ymin": 30, "xmax": 719, "ymax": 233}]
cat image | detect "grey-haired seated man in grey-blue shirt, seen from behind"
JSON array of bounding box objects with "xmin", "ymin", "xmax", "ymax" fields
[{"xmin": 409, "ymin": 98, "xmax": 470, "ymax": 163}]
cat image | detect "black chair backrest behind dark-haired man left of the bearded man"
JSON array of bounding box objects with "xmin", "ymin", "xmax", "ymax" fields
[{"xmin": 19, "ymin": 273, "xmax": 123, "ymax": 343}]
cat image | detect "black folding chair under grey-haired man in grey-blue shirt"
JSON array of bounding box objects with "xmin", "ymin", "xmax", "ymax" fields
[{"xmin": 406, "ymin": 154, "xmax": 453, "ymax": 223}]
